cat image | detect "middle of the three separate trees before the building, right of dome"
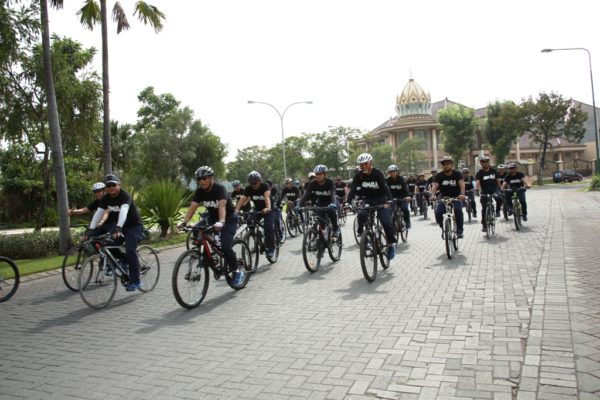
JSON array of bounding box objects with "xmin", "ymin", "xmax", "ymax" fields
[{"xmin": 483, "ymin": 101, "xmax": 523, "ymax": 164}]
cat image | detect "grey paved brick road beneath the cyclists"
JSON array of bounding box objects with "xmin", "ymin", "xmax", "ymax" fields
[{"xmin": 0, "ymin": 186, "xmax": 600, "ymax": 400}]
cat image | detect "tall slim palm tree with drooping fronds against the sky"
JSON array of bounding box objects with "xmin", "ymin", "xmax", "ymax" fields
[{"xmin": 78, "ymin": 0, "xmax": 165, "ymax": 174}]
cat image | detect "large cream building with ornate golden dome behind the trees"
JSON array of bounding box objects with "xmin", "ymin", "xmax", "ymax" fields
[{"xmin": 357, "ymin": 78, "xmax": 596, "ymax": 173}]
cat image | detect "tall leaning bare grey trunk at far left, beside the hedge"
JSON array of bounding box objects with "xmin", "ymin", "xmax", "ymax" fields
[{"xmin": 40, "ymin": 0, "xmax": 71, "ymax": 254}]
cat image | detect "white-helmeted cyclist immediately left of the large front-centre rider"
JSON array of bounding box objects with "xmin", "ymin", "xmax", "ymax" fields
[{"xmin": 296, "ymin": 164, "xmax": 340, "ymax": 236}]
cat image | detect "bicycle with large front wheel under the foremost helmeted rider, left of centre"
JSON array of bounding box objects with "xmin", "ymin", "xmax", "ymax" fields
[{"xmin": 171, "ymin": 225, "xmax": 252, "ymax": 309}]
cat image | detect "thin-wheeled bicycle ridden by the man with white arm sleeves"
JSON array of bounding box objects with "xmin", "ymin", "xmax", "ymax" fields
[{"xmin": 78, "ymin": 233, "xmax": 160, "ymax": 310}]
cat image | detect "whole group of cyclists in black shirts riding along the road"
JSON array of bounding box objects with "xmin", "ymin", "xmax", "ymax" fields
[{"xmin": 75, "ymin": 153, "xmax": 527, "ymax": 291}]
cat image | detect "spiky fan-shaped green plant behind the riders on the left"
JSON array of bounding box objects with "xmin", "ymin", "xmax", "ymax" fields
[{"xmin": 137, "ymin": 179, "xmax": 189, "ymax": 237}]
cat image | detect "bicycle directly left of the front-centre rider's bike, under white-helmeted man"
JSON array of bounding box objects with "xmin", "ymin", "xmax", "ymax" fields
[{"xmin": 302, "ymin": 207, "xmax": 343, "ymax": 273}]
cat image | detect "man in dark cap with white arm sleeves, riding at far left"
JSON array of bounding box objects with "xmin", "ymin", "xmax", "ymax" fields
[{"xmin": 90, "ymin": 174, "xmax": 144, "ymax": 292}]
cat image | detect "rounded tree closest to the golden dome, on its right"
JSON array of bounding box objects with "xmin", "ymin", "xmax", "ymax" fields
[{"xmin": 438, "ymin": 105, "xmax": 476, "ymax": 162}]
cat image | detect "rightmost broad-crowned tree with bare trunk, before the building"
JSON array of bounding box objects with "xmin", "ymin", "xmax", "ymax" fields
[{"xmin": 520, "ymin": 92, "xmax": 587, "ymax": 185}]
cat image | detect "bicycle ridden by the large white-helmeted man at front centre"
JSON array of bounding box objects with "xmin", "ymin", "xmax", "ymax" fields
[{"xmin": 359, "ymin": 204, "xmax": 390, "ymax": 282}]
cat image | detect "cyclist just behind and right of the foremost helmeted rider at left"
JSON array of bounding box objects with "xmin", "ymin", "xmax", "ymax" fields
[{"xmin": 235, "ymin": 171, "xmax": 275, "ymax": 258}]
